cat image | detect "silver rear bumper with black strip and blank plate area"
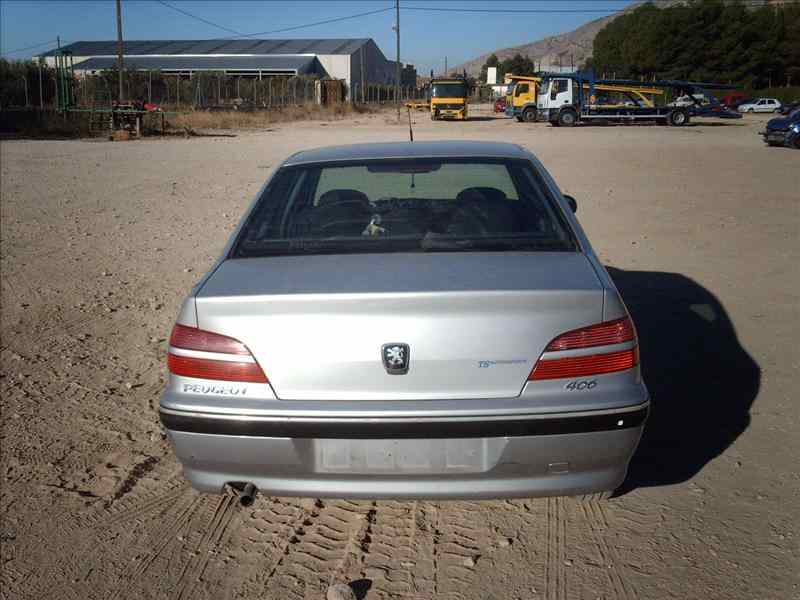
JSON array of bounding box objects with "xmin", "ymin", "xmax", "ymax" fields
[{"xmin": 161, "ymin": 403, "xmax": 649, "ymax": 499}]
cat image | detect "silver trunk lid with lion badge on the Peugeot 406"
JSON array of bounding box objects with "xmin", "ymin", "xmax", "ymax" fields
[{"xmin": 196, "ymin": 252, "xmax": 603, "ymax": 400}]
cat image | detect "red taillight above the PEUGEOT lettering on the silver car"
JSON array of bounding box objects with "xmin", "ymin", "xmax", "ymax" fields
[{"xmin": 167, "ymin": 324, "xmax": 269, "ymax": 383}]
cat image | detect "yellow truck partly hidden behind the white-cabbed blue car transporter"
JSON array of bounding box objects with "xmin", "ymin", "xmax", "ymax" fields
[{"xmin": 505, "ymin": 74, "xmax": 664, "ymax": 123}]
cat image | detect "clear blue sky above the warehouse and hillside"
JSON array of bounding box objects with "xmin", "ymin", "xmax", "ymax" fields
[{"xmin": 0, "ymin": 0, "xmax": 632, "ymax": 73}]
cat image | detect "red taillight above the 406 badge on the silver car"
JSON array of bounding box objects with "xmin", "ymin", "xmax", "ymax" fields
[{"xmin": 528, "ymin": 317, "xmax": 639, "ymax": 381}]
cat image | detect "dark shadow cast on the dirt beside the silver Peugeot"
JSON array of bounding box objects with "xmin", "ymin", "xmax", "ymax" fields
[{"xmin": 608, "ymin": 268, "xmax": 761, "ymax": 495}]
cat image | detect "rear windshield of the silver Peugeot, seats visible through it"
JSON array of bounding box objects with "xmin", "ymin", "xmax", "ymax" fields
[{"xmin": 231, "ymin": 159, "xmax": 577, "ymax": 257}]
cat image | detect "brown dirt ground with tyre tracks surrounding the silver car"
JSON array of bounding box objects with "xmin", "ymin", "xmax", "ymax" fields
[{"xmin": 0, "ymin": 109, "xmax": 800, "ymax": 600}]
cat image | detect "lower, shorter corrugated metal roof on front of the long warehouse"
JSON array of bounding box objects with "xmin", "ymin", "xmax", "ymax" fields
[{"xmin": 75, "ymin": 55, "xmax": 323, "ymax": 75}]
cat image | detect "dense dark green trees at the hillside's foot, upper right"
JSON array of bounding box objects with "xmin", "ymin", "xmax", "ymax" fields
[{"xmin": 591, "ymin": 0, "xmax": 800, "ymax": 87}]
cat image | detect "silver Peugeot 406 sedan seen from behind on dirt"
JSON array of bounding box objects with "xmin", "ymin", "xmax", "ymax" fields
[{"xmin": 160, "ymin": 142, "xmax": 649, "ymax": 498}]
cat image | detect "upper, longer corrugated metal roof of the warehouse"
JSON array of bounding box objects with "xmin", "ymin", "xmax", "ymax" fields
[{"xmin": 42, "ymin": 38, "xmax": 369, "ymax": 56}]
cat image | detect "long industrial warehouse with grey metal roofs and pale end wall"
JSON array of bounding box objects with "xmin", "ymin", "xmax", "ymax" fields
[{"xmin": 39, "ymin": 38, "xmax": 406, "ymax": 98}]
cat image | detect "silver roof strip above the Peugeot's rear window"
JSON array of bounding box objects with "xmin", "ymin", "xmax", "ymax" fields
[{"xmin": 283, "ymin": 140, "xmax": 530, "ymax": 166}]
